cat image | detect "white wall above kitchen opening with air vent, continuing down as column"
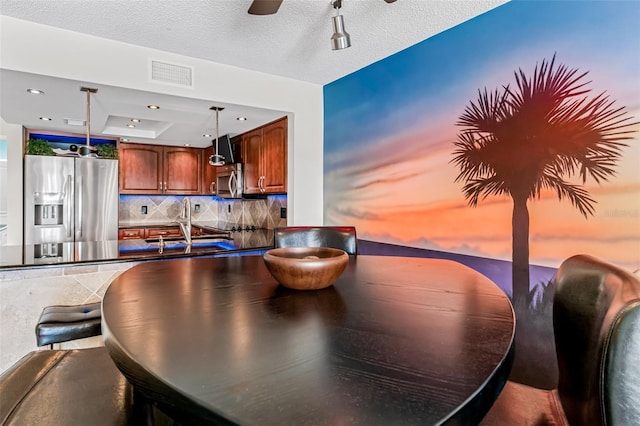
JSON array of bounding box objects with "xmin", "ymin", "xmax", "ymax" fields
[{"xmin": 0, "ymin": 16, "xmax": 323, "ymax": 225}]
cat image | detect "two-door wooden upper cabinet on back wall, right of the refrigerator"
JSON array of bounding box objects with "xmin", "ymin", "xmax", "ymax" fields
[{"xmin": 119, "ymin": 144, "xmax": 203, "ymax": 195}]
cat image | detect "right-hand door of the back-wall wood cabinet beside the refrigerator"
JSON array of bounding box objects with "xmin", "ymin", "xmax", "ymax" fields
[{"xmin": 164, "ymin": 146, "xmax": 202, "ymax": 194}]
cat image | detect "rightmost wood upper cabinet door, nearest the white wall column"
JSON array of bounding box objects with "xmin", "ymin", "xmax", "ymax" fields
[{"xmin": 261, "ymin": 117, "xmax": 288, "ymax": 194}]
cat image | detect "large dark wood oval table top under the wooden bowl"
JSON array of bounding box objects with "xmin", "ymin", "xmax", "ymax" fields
[{"xmin": 102, "ymin": 256, "xmax": 515, "ymax": 426}]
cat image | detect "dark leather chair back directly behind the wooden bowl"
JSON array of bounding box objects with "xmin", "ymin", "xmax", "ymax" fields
[{"xmin": 273, "ymin": 226, "xmax": 358, "ymax": 254}]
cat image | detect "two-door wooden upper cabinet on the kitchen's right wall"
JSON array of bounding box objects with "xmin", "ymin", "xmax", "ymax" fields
[{"xmin": 242, "ymin": 117, "xmax": 288, "ymax": 194}]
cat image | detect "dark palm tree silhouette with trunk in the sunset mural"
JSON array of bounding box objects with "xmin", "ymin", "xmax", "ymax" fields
[{"xmin": 452, "ymin": 55, "xmax": 637, "ymax": 303}]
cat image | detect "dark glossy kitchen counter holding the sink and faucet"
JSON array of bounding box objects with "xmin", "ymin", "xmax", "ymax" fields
[{"xmin": 0, "ymin": 226, "xmax": 273, "ymax": 269}]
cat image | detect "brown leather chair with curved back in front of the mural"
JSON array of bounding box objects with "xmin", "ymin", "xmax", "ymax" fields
[{"xmin": 481, "ymin": 255, "xmax": 640, "ymax": 426}]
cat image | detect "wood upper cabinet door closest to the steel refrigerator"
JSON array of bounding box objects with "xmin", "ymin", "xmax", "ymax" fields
[{"xmin": 119, "ymin": 144, "xmax": 163, "ymax": 194}]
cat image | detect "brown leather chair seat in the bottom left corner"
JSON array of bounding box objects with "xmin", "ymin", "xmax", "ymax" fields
[{"xmin": 0, "ymin": 347, "xmax": 152, "ymax": 426}]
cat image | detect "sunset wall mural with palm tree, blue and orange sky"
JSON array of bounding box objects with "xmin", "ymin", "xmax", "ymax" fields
[{"xmin": 323, "ymin": 0, "xmax": 640, "ymax": 389}]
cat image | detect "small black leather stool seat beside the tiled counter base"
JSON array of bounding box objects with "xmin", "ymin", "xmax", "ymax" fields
[{"xmin": 36, "ymin": 302, "xmax": 102, "ymax": 349}]
